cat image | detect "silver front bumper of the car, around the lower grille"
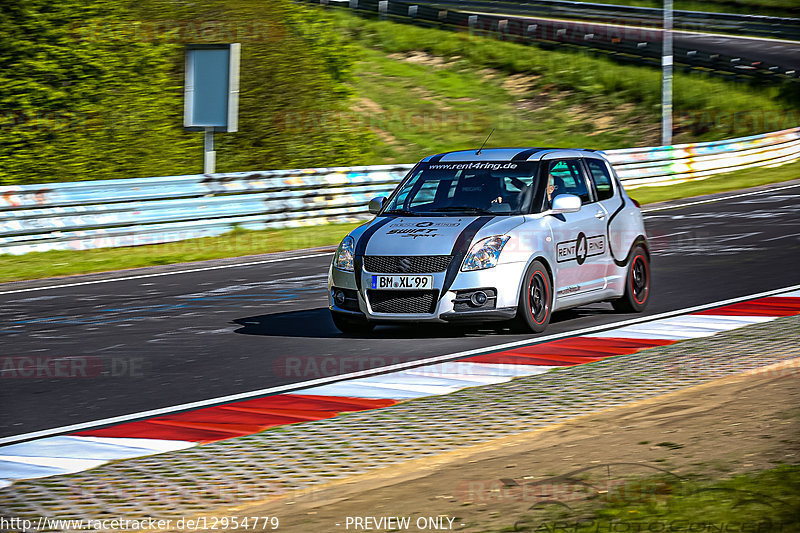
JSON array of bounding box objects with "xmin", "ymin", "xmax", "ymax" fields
[{"xmin": 328, "ymin": 263, "xmax": 526, "ymax": 323}]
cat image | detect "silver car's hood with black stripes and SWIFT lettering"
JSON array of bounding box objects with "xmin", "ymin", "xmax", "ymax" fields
[{"xmin": 360, "ymin": 216, "xmax": 524, "ymax": 255}]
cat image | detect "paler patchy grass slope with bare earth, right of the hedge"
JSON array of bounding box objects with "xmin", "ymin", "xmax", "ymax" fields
[{"xmin": 355, "ymin": 50, "xmax": 658, "ymax": 163}]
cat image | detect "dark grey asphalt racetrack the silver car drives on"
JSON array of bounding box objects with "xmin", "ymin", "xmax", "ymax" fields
[{"xmin": 0, "ymin": 181, "xmax": 800, "ymax": 437}]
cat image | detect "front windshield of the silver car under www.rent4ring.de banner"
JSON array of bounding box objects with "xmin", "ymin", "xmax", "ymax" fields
[{"xmin": 383, "ymin": 161, "xmax": 538, "ymax": 216}]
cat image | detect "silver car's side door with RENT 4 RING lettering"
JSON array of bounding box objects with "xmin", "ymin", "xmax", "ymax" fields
[{"xmin": 545, "ymin": 158, "xmax": 609, "ymax": 300}]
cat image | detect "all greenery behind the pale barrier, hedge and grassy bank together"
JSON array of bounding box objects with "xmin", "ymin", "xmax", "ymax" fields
[{"xmin": 0, "ymin": 0, "xmax": 800, "ymax": 185}]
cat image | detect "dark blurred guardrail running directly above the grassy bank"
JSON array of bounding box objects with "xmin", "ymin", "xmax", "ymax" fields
[{"xmin": 314, "ymin": 0, "xmax": 800, "ymax": 81}]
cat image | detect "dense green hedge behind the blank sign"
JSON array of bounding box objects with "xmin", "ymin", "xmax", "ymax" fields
[{"xmin": 0, "ymin": 0, "xmax": 373, "ymax": 185}]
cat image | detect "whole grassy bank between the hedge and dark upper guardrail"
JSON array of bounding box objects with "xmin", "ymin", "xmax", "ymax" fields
[{"xmin": 330, "ymin": 9, "xmax": 800, "ymax": 163}]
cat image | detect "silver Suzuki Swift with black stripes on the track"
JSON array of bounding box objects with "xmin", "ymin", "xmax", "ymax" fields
[{"xmin": 328, "ymin": 148, "xmax": 650, "ymax": 333}]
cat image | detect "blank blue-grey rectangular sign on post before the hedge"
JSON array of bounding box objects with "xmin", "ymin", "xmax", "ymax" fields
[{"xmin": 183, "ymin": 43, "xmax": 241, "ymax": 174}]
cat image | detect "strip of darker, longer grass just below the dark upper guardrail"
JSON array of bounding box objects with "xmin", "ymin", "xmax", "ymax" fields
[{"xmin": 334, "ymin": 10, "xmax": 800, "ymax": 142}]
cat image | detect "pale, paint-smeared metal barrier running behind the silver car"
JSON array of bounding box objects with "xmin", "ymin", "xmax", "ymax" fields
[{"xmin": 0, "ymin": 127, "xmax": 800, "ymax": 255}]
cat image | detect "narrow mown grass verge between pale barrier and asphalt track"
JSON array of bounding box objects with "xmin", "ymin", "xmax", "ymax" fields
[{"xmin": 0, "ymin": 163, "xmax": 800, "ymax": 282}]
